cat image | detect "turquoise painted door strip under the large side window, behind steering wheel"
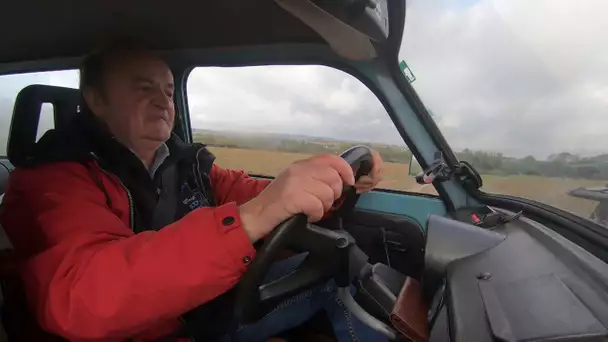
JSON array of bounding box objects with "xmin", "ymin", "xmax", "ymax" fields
[{"xmin": 356, "ymin": 191, "xmax": 447, "ymax": 229}]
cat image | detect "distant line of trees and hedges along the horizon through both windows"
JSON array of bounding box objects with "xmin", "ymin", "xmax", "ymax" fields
[{"xmin": 194, "ymin": 132, "xmax": 608, "ymax": 180}]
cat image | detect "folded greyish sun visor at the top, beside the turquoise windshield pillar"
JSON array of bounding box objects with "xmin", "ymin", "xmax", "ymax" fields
[{"xmin": 275, "ymin": 0, "xmax": 378, "ymax": 61}]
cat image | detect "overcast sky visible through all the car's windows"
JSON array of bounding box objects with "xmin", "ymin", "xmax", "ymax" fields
[{"xmin": 0, "ymin": 0, "xmax": 608, "ymax": 158}]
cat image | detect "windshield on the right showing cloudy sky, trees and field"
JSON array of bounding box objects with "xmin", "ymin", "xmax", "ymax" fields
[{"xmin": 400, "ymin": 0, "xmax": 608, "ymax": 224}]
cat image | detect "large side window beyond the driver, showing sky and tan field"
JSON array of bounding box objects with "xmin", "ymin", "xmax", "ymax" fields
[{"xmin": 187, "ymin": 66, "xmax": 434, "ymax": 193}]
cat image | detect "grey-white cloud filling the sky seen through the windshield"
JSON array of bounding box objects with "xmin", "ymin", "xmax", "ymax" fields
[{"xmin": 401, "ymin": 0, "xmax": 608, "ymax": 157}]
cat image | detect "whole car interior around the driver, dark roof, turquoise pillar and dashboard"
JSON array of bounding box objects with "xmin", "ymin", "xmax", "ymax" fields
[{"xmin": 0, "ymin": 0, "xmax": 608, "ymax": 342}]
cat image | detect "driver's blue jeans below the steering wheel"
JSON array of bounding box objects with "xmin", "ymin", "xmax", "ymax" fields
[{"xmin": 222, "ymin": 254, "xmax": 388, "ymax": 342}]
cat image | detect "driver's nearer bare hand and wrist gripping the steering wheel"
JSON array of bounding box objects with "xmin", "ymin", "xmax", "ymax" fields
[{"xmin": 239, "ymin": 154, "xmax": 355, "ymax": 243}]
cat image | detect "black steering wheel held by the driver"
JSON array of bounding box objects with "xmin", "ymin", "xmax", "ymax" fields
[{"xmin": 235, "ymin": 146, "xmax": 372, "ymax": 324}]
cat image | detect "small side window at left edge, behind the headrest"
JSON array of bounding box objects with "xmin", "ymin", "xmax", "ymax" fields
[{"xmin": 0, "ymin": 70, "xmax": 78, "ymax": 156}]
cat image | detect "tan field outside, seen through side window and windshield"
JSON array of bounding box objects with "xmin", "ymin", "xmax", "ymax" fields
[{"xmin": 209, "ymin": 147, "xmax": 606, "ymax": 217}]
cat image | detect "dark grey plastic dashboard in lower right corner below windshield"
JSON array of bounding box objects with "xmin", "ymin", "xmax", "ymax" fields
[{"xmin": 446, "ymin": 212, "xmax": 608, "ymax": 342}]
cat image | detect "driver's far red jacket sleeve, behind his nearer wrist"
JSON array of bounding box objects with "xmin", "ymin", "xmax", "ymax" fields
[{"xmin": 210, "ymin": 164, "xmax": 270, "ymax": 205}]
